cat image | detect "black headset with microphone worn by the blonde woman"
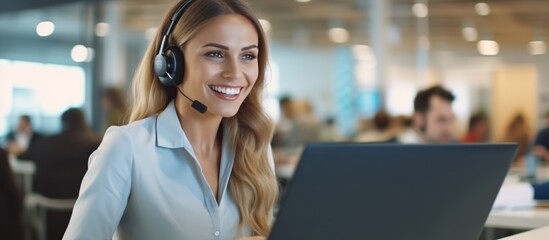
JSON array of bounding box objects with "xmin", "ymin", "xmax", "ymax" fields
[{"xmin": 153, "ymin": 0, "xmax": 208, "ymax": 113}]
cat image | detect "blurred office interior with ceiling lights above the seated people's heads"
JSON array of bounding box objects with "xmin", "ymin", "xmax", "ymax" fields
[{"xmin": 0, "ymin": 0, "xmax": 549, "ymax": 139}]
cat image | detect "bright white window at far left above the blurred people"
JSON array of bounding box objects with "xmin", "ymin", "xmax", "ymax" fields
[{"xmin": 0, "ymin": 59, "xmax": 85, "ymax": 136}]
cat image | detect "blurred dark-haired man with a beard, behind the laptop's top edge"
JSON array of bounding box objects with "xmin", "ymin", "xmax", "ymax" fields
[{"xmin": 399, "ymin": 86, "xmax": 455, "ymax": 143}]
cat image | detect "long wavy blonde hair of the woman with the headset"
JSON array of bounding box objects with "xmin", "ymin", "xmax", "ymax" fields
[{"xmin": 129, "ymin": 0, "xmax": 278, "ymax": 236}]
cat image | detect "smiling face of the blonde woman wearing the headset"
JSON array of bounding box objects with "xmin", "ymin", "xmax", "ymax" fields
[{"xmin": 182, "ymin": 14, "xmax": 259, "ymax": 117}]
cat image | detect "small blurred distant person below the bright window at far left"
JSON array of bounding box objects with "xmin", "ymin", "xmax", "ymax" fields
[{"xmin": 7, "ymin": 115, "xmax": 42, "ymax": 160}]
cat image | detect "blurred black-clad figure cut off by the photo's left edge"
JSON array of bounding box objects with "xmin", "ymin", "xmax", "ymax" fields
[{"xmin": 0, "ymin": 148, "xmax": 24, "ymax": 240}]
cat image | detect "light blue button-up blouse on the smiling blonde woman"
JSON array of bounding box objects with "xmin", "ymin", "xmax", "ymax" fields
[{"xmin": 63, "ymin": 101, "xmax": 274, "ymax": 240}]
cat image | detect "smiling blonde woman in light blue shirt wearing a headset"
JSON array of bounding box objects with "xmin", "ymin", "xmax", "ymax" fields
[{"xmin": 65, "ymin": 0, "xmax": 278, "ymax": 239}]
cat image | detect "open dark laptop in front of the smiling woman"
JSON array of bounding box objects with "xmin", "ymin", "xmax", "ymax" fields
[{"xmin": 269, "ymin": 143, "xmax": 517, "ymax": 240}]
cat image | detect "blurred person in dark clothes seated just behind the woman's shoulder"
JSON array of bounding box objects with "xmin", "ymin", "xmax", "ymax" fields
[{"xmin": 32, "ymin": 108, "xmax": 101, "ymax": 239}]
